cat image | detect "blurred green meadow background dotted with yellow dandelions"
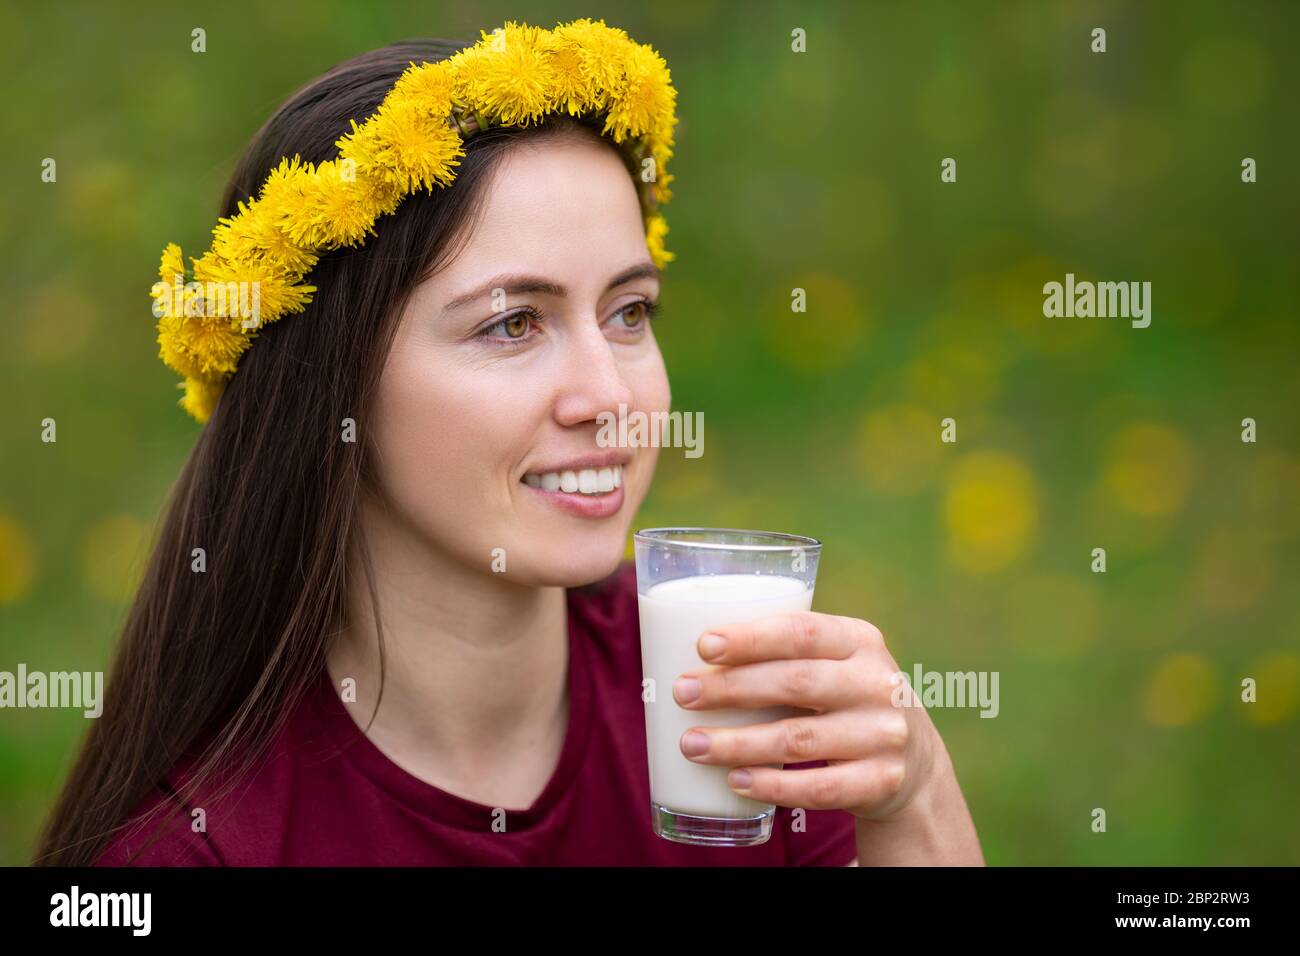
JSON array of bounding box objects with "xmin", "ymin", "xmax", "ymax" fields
[{"xmin": 0, "ymin": 0, "xmax": 1300, "ymax": 865}]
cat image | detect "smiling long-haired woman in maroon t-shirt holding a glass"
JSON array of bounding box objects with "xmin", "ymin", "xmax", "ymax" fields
[{"xmin": 36, "ymin": 21, "xmax": 983, "ymax": 865}]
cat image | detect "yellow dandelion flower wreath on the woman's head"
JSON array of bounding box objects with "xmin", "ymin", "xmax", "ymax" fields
[{"xmin": 151, "ymin": 20, "xmax": 676, "ymax": 423}]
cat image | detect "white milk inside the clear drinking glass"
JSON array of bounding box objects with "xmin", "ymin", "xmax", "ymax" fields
[{"xmin": 638, "ymin": 574, "xmax": 813, "ymax": 817}]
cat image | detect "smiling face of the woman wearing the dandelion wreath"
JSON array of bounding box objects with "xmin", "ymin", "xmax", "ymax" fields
[{"xmin": 376, "ymin": 130, "xmax": 671, "ymax": 587}]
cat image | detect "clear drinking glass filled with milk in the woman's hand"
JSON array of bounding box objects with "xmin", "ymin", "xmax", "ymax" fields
[{"xmin": 633, "ymin": 528, "xmax": 822, "ymax": 847}]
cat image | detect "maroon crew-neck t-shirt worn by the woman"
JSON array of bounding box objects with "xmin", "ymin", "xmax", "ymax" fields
[{"xmin": 98, "ymin": 563, "xmax": 857, "ymax": 866}]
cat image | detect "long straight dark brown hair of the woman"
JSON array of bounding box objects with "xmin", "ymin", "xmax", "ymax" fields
[{"xmin": 34, "ymin": 40, "xmax": 647, "ymax": 866}]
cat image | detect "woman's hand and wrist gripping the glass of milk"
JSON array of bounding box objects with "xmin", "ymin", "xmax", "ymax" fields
[{"xmin": 672, "ymin": 611, "xmax": 983, "ymax": 864}]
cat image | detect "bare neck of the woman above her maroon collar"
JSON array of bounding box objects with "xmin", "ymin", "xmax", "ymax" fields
[{"xmin": 326, "ymin": 502, "xmax": 568, "ymax": 808}]
